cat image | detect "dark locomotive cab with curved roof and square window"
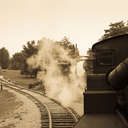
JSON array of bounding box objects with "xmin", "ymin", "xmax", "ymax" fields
[{"xmin": 92, "ymin": 34, "xmax": 128, "ymax": 74}]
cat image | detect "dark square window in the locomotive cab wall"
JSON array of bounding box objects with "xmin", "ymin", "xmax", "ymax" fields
[{"xmin": 96, "ymin": 49, "xmax": 115, "ymax": 66}]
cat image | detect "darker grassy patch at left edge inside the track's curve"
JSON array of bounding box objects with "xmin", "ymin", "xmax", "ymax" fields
[{"xmin": 0, "ymin": 90, "xmax": 20, "ymax": 128}]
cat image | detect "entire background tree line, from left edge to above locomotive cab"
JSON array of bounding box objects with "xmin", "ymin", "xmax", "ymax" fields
[{"xmin": 0, "ymin": 21, "xmax": 128, "ymax": 77}]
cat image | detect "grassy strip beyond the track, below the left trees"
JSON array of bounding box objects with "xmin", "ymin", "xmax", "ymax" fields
[{"xmin": 0, "ymin": 69, "xmax": 38, "ymax": 88}]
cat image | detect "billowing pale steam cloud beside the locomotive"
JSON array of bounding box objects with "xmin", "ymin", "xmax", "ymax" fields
[{"xmin": 27, "ymin": 38, "xmax": 85, "ymax": 106}]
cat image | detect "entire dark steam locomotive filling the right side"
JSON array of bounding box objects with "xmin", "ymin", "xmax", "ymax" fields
[{"xmin": 75, "ymin": 34, "xmax": 128, "ymax": 128}]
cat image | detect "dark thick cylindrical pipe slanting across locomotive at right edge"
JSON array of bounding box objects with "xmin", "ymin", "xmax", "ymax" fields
[{"xmin": 106, "ymin": 58, "xmax": 128, "ymax": 90}]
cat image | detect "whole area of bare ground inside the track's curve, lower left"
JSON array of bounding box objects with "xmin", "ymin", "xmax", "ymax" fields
[{"xmin": 0, "ymin": 89, "xmax": 40, "ymax": 128}]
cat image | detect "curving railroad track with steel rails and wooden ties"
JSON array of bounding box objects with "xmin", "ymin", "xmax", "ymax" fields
[{"xmin": 0, "ymin": 79, "xmax": 79, "ymax": 128}]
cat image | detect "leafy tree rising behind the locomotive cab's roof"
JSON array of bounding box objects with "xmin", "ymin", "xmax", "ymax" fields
[{"xmin": 100, "ymin": 21, "xmax": 128, "ymax": 41}]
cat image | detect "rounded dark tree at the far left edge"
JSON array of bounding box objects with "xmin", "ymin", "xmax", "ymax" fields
[{"xmin": 0, "ymin": 47, "xmax": 10, "ymax": 69}]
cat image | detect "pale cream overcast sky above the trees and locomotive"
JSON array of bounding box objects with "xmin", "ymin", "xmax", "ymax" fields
[{"xmin": 0, "ymin": 0, "xmax": 128, "ymax": 55}]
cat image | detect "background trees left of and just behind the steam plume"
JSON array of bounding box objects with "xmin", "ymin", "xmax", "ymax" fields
[{"xmin": 0, "ymin": 37, "xmax": 79, "ymax": 77}]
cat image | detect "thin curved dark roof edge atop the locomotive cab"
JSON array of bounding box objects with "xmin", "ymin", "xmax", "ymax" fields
[{"xmin": 92, "ymin": 34, "xmax": 128, "ymax": 51}]
